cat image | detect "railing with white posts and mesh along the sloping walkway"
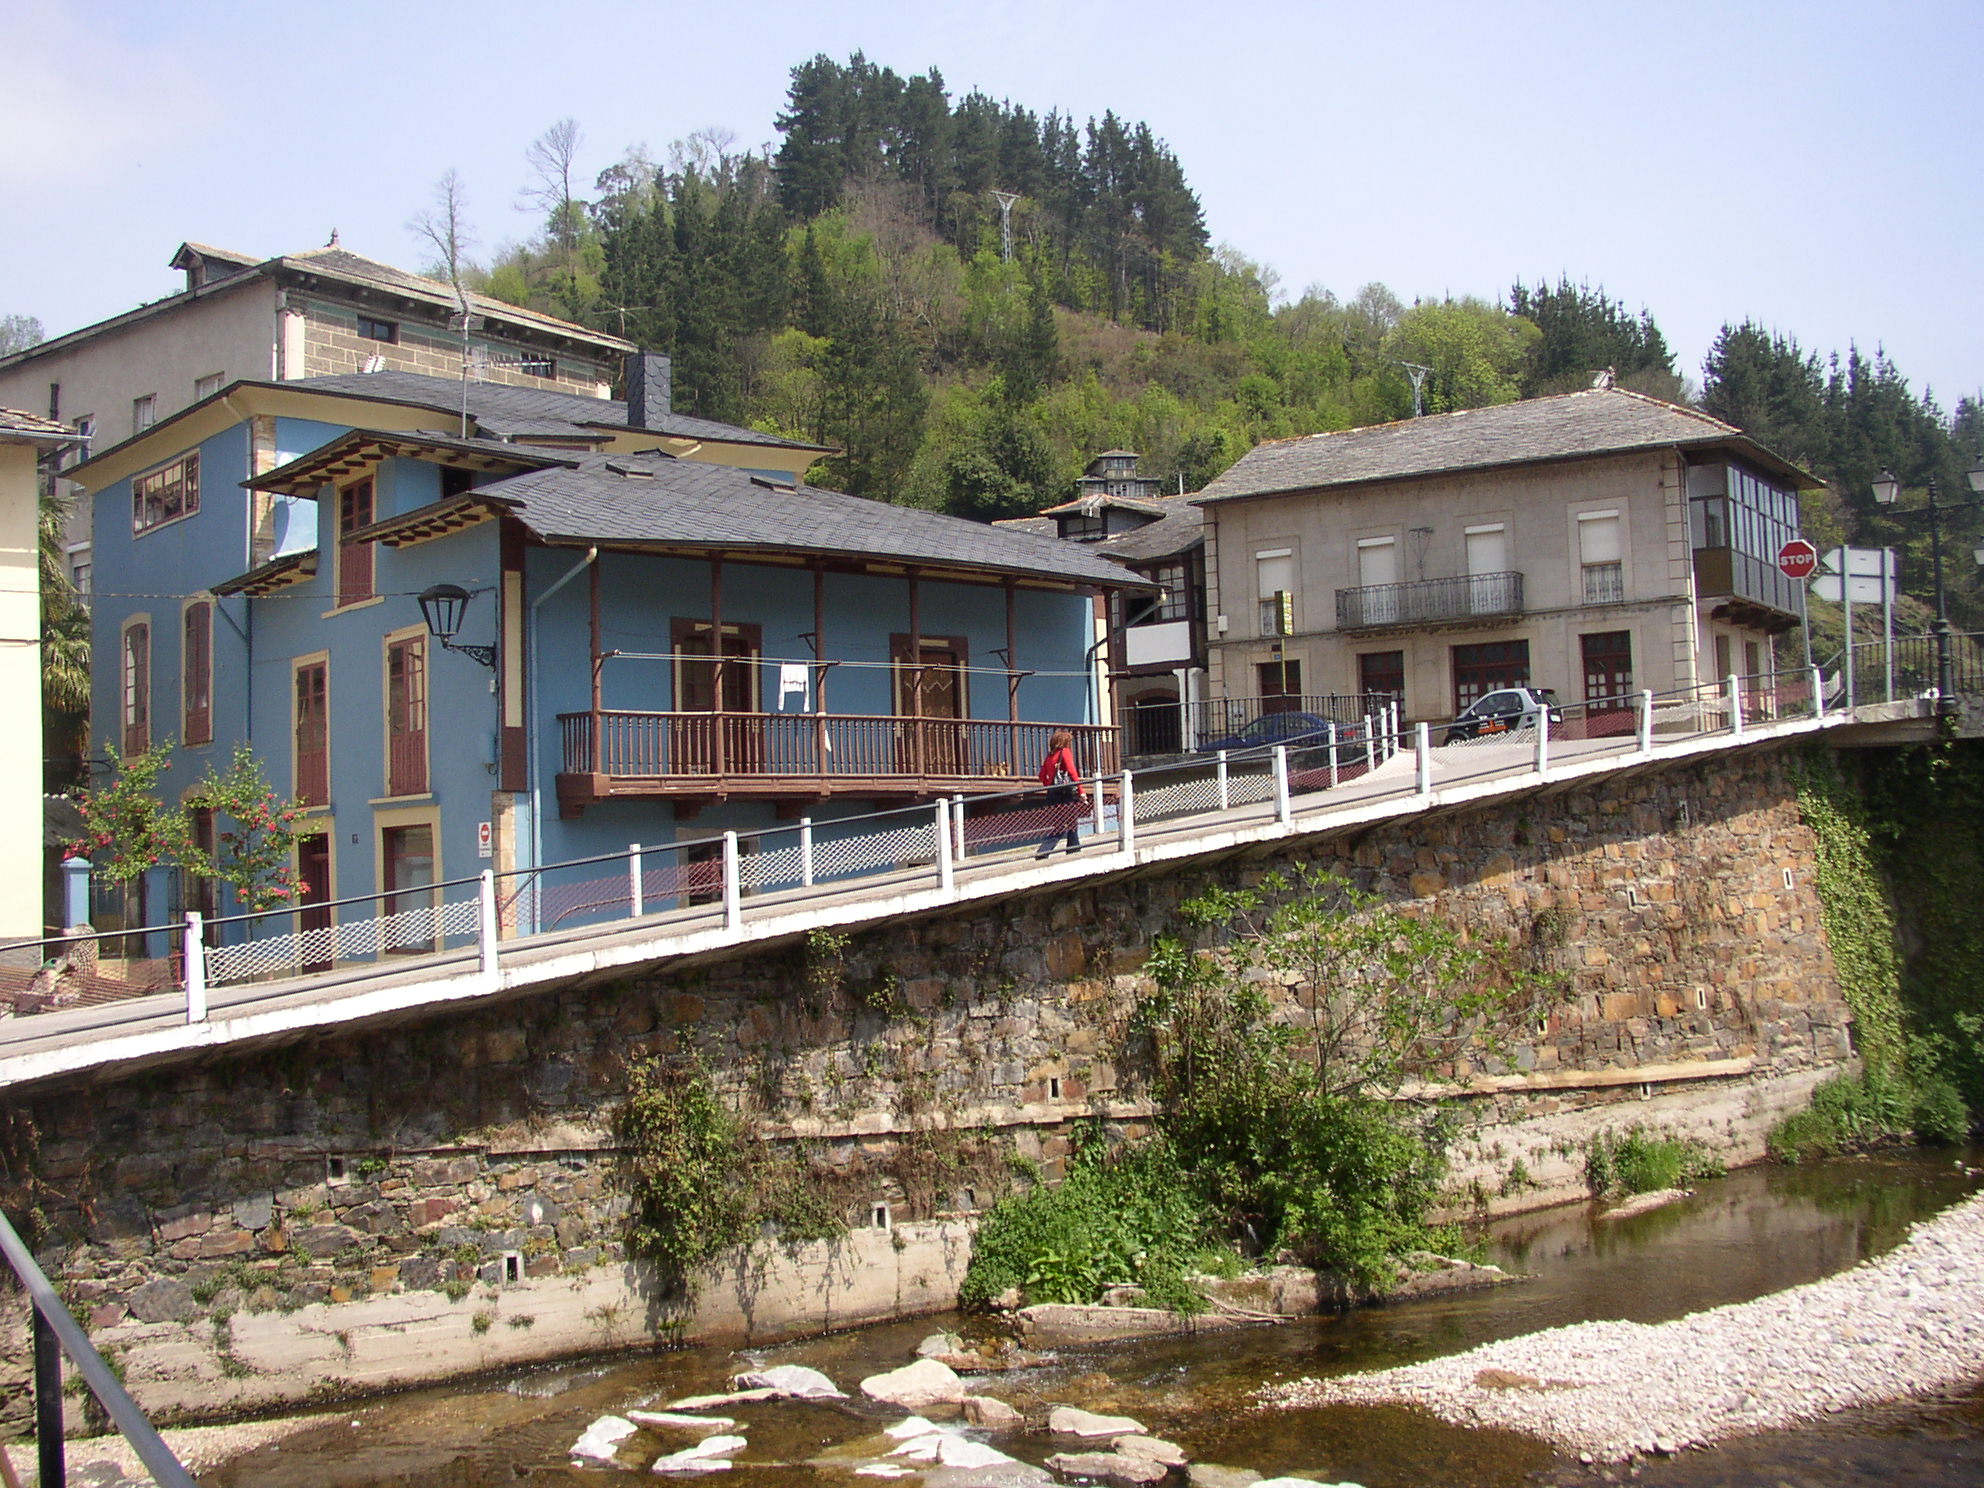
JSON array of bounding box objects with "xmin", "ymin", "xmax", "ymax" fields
[{"xmin": 0, "ymin": 669, "xmax": 1833, "ymax": 1022}]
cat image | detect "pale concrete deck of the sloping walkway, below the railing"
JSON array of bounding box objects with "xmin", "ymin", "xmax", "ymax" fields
[{"xmin": 0, "ymin": 702, "xmax": 1934, "ymax": 1089}]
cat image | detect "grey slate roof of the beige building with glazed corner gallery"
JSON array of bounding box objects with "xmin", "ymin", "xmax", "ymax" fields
[{"xmin": 1194, "ymin": 387, "xmax": 1821, "ymax": 504}]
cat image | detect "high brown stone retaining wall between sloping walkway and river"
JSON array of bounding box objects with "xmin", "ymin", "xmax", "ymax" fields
[{"xmin": 0, "ymin": 750, "xmax": 1849, "ymax": 1411}]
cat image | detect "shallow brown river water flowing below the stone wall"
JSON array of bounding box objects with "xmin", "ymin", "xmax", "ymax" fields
[{"xmin": 202, "ymin": 1151, "xmax": 1984, "ymax": 1488}]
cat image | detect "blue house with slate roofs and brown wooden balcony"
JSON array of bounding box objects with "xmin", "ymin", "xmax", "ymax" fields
[{"xmin": 69, "ymin": 357, "xmax": 1141, "ymax": 944}]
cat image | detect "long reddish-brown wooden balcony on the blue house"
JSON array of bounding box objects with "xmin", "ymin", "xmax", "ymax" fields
[{"xmin": 558, "ymin": 710, "xmax": 1117, "ymax": 815}]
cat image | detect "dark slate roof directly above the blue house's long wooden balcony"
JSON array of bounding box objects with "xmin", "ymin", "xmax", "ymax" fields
[{"xmin": 458, "ymin": 452, "xmax": 1145, "ymax": 587}]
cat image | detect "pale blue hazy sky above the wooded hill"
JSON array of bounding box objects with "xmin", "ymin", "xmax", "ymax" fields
[{"xmin": 0, "ymin": 0, "xmax": 1984, "ymax": 411}]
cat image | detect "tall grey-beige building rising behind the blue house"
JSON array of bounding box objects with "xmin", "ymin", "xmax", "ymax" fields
[{"xmin": 0, "ymin": 234, "xmax": 633, "ymax": 589}]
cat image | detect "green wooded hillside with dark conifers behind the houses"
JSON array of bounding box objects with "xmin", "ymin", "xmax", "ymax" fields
[{"xmin": 456, "ymin": 54, "xmax": 1984, "ymax": 623}]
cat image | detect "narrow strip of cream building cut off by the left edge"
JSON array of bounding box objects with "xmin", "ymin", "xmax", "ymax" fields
[{"xmin": 0, "ymin": 407, "xmax": 75, "ymax": 944}]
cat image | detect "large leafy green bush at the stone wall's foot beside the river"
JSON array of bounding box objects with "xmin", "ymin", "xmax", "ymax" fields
[{"xmin": 964, "ymin": 869, "xmax": 1551, "ymax": 1305}]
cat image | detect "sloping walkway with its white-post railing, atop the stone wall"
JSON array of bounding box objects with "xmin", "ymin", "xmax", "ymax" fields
[{"xmin": 0, "ymin": 665, "xmax": 1968, "ymax": 1089}]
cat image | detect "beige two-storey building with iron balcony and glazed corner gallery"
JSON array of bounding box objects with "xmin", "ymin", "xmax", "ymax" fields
[{"xmin": 1196, "ymin": 387, "xmax": 1819, "ymax": 718}]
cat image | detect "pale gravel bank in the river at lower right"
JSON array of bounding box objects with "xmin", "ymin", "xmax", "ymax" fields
[{"xmin": 1262, "ymin": 1196, "xmax": 1984, "ymax": 1460}]
